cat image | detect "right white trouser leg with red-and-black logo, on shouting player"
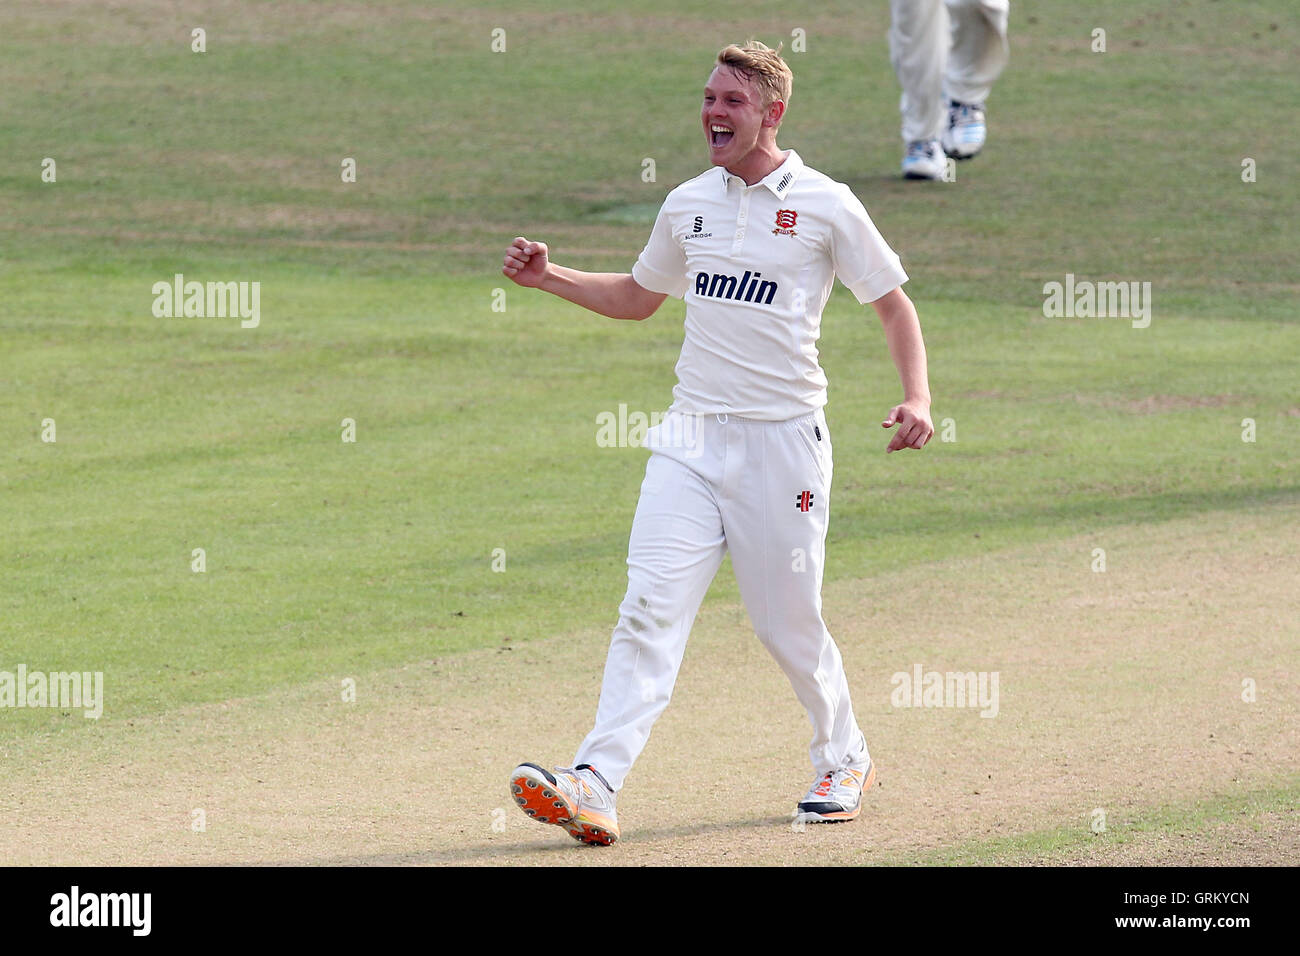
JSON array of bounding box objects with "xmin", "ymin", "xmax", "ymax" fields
[{"xmin": 722, "ymin": 415, "xmax": 868, "ymax": 774}]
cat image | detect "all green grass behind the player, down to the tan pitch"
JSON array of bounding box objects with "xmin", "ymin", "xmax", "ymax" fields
[{"xmin": 0, "ymin": 0, "xmax": 1300, "ymax": 740}]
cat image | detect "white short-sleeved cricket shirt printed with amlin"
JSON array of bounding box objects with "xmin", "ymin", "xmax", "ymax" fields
[{"xmin": 632, "ymin": 150, "xmax": 907, "ymax": 421}]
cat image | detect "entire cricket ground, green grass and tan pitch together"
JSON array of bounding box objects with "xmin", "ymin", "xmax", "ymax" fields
[{"xmin": 0, "ymin": 0, "xmax": 1300, "ymax": 864}]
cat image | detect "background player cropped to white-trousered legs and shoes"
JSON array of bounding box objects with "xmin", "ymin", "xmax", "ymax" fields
[{"xmin": 889, "ymin": 0, "xmax": 1011, "ymax": 179}]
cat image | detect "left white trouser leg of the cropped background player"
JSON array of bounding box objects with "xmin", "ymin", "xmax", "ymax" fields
[{"xmin": 889, "ymin": 0, "xmax": 952, "ymax": 143}]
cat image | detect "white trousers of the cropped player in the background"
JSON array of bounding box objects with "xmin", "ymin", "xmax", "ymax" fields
[{"xmin": 889, "ymin": 0, "xmax": 1010, "ymax": 143}]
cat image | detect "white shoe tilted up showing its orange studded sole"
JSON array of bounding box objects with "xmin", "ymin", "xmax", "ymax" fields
[{"xmin": 510, "ymin": 763, "xmax": 619, "ymax": 847}]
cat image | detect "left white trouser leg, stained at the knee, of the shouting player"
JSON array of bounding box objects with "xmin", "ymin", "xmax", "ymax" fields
[{"xmin": 573, "ymin": 434, "xmax": 725, "ymax": 790}]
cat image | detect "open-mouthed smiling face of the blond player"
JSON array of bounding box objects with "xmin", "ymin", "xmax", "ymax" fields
[{"xmin": 699, "ymin": 66, "xmax": 785, "ymax": 179}]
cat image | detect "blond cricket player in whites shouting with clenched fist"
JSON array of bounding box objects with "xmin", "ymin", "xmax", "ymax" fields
[{"xmin": 502, "ymin": 40, "xmax": 935, "ymax": 844}]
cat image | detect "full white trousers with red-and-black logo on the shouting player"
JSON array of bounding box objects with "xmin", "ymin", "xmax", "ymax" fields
[{"xmin": 573, "ymin": 411, "xmax": 868, "ymax": 790}]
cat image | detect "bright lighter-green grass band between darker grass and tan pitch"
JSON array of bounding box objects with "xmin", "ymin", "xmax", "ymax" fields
[{"xmin": 0, "ymin": 271, "xmax": 1300, "ymax": 726}]
